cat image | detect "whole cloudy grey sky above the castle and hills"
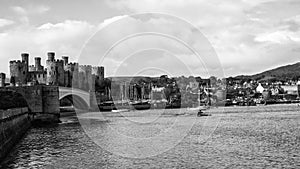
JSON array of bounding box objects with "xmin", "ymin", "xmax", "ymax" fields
[{"xmin": 0, "ymin": 0, "xmax": 300, "ymax": 77}]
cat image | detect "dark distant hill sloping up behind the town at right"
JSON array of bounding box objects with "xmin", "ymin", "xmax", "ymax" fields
[{"xmin": 235, "ymin": 62, "xmax": 300, "ymax": 81}]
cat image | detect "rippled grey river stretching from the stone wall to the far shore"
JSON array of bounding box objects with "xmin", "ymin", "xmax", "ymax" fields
[{"xmin": 0, "ymin": 105, "xmax": 300, "ymax": 168}]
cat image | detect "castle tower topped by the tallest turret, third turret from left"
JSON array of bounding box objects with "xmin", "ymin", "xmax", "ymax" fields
[{"xmin": 46, "ymin": 52, "xmax": 58, "ymax": 85}]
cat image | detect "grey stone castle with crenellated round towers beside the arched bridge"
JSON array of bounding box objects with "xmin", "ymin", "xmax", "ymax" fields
[{"xmin": 9, "ymin": 52, "xmax": 104, "ymax": 91}]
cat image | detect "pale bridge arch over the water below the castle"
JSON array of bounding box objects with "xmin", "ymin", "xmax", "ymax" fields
[{"xmin": 59, "ymin": 87, "xmax": 91, "ymax": 110}]
